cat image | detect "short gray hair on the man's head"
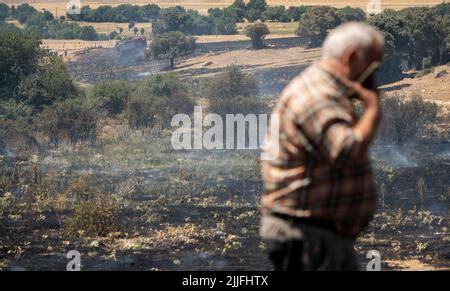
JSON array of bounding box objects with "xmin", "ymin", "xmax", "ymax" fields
[{"xmin": 322, "ymin": 22, "xmax": 384, "ymax": 58}]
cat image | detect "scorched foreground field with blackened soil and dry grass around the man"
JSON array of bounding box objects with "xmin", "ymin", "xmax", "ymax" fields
[{"xmin": 1, "ymin": 120, "xmax": 450, "ymax": 270}]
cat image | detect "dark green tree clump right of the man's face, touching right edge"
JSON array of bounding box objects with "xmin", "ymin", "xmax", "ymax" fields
[{"xmin": 368, "ymin": 4, "xmax": 450, "ymax": 81}]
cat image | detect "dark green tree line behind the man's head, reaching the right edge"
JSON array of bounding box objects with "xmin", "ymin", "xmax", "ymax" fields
[{"xmin": 297, "ymin": 3, "xmax": 450, "ymax": 82}]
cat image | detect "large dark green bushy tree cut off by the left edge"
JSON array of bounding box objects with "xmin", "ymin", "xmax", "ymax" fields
[{"xmin": 0, "ymin": 27, "xmax": 80, "ymax": 113}]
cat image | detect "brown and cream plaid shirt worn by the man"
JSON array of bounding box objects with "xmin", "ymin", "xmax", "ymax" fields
[{"xmin": 261, "ymin": 64, "xmax": 376, "ymax": 238}]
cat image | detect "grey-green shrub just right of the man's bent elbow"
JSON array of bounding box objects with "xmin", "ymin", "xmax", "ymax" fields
[{"xmin": 379, "ymin": 95, "xmax": 439, "ymax": 144}]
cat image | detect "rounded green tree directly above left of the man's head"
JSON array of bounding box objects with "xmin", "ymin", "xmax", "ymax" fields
[{"xmin": 297, "ymin": 6, "xmax": 342, "ymax": 46}]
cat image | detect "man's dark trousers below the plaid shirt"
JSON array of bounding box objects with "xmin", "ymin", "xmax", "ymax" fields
[{"xmin": 261, "ymin": 217, "xmax": 358, "ymax": 271}]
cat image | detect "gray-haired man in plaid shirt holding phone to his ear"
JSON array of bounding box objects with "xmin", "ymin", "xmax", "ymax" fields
[{"xmin": 260, "ymin": 23, "xmax": 384, "ymax": 270}]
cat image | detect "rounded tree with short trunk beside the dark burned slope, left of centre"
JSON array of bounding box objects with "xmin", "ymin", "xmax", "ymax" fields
[{"xmin": 146, "ymin": 31, "xmax": 196, "ymax": 68}]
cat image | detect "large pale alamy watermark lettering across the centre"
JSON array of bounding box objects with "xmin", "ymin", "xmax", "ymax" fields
[{"xmin": 171, "ymin": 106, "xmax": 279, "ymax": 160}]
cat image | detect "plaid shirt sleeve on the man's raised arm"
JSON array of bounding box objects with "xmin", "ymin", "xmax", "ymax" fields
[{"xmin": 297, "ymin": 100, "xmax": 361, "ymax": 167}]
